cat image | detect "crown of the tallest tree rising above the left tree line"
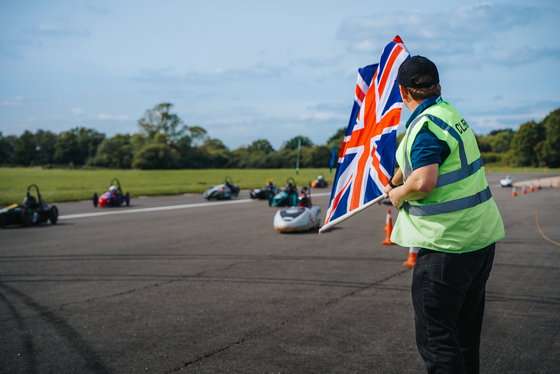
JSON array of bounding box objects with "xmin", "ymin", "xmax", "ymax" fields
[{"xmin": 138, "ymin": 103, "xmax": 188, "ymax": 143}]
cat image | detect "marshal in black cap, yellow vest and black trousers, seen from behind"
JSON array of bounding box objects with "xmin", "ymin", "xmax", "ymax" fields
[{"xmin": 385, "ymin": 56, "xmax": 505, "ymax": 374}]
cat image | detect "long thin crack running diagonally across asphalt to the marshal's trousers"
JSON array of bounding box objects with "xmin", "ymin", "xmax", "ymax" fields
[{"xmin": 164, "ymin": 269, "xmax": 411, "ymax": 374}]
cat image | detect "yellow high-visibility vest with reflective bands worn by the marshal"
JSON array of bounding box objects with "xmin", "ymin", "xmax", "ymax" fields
[{"xmin": 391, "ymin": 101, "xmax": 505, "ymax": 253}]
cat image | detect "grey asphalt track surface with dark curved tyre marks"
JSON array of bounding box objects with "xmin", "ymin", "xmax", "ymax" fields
[{"xmin": 0, "ymin": 174, "xmax": 560, "ymax": 373}]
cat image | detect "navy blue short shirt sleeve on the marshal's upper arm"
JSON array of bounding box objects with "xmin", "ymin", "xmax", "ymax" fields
[{"xmin": 410, "ymin": 126, "xmax": 450, "ymax": 170}]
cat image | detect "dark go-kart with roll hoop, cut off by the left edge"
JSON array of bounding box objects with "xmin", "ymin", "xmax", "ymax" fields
[{"xmin": 0, "ymin": 184, "xmax": 58, "ymax": 227}]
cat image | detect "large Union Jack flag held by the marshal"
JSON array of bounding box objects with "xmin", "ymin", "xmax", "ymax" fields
[{"xmin": 325, "ymin": 35, "xmax": 410, "ymax": 224}]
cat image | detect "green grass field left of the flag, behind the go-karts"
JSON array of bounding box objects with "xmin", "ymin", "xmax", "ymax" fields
[{"xmin": 0, "ymin": 168, "xmax": 334, "ymax": 207}]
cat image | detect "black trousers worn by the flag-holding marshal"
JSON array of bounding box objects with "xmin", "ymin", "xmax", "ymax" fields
[{"xmin": 412, "ymin": 244, "xmax": 496, "ymax": 374}]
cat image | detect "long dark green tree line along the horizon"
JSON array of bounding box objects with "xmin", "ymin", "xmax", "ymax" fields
[{"xmin": 0, "ymin": 103, "xmax": 560, "ymax": 169}]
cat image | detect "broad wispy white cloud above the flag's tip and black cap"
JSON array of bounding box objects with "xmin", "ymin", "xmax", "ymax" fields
[{"xmin": 337, "ymin": 3, "xmax": 560, "ymax": 65}]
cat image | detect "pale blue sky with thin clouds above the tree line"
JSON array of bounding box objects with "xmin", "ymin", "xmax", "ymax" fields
[{"xmin": 0, "ymin": 0, "xmax": 560, "ymax": 150}]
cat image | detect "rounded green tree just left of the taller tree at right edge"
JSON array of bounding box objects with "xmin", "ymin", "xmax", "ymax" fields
[{"xmin": 511, "ymin": 121, "xmax": 545, "ymax": 166}]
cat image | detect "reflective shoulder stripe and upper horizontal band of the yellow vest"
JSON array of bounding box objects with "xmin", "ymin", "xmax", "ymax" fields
[{"xmin": 404, "ymin": 114, "xmax": 483, "ymax": 188}]
